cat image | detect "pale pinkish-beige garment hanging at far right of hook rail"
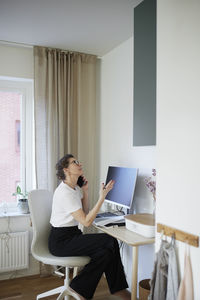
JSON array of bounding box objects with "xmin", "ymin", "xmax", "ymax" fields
[{"xmin": 177, "ymin": 245, "xmax": 194, "ymax": 300}]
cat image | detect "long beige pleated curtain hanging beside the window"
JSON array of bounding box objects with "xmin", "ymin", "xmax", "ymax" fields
[{"xmin": 34, "ymin": 47, "xmax": 96, "ymax": 204}]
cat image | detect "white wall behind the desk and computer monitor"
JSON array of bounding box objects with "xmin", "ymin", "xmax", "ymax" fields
[{"xmin": 98, "ymin": 38, "xmax": 156, "ymax": 292}]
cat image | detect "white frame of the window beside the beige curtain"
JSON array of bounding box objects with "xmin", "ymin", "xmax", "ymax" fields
[{"xmin": 0, "ymin": 76, "xmax": 36, "ymax": 206}]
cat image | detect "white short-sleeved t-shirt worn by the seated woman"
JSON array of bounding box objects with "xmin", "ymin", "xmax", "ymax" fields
[{"xmin": 50, "ymin": 182, "xmax": 83, "ymax": 227}]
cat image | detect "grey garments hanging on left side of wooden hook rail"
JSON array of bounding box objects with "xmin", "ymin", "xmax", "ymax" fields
[{"xmin": 148, "ymin": 240, "xmax": 179, "ymax": 300}]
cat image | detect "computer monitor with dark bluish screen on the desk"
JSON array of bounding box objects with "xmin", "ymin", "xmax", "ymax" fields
[{"xmin": 105, "ymin": 166, "xmax": 138, "ymax": 209}]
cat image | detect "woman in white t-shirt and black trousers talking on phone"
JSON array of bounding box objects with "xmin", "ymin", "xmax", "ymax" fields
[{"xmin": 49, "ymin": 154, "xmax": 131, "ymax": 300}]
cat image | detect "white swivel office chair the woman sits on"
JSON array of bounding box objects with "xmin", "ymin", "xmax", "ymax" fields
[{"xmin": 28, "ymin": 190, "xmax": 90, "ymax": 300}]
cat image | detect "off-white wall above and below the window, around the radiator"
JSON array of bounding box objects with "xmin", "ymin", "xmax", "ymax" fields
[{"xmin": 0, "ymin": 44, "xmax": 39, "ymax": 280}]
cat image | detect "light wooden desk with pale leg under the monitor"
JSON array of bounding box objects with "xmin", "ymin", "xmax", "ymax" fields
[{"xmin": 95, "ymin": 226, "xmax": 155, "ymax": 300}]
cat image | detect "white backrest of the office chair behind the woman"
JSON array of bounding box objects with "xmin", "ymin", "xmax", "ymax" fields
[{"xmin": 28, "ymin": 190, "xmax": 53, "ymax": 259}]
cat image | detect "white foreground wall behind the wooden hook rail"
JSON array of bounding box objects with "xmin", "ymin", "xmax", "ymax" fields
[{"xmin": 157, "ymin": 0, "xmax": 200, "ymax": 300}]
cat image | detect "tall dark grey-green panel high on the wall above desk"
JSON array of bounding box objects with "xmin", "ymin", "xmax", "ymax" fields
[{"xmin": 133, "ymin": 0, "xmax": 156, "ymax": 146}]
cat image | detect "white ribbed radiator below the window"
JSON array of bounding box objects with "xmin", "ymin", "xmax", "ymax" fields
[{"xmin": 0, "ymin": 231, "xmax": 29, "ymax": 272}]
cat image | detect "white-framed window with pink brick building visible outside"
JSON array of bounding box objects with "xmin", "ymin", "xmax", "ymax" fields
[{"xmin": 0, "ymin": 77, "xmax": 35, "ymax": 203}]
